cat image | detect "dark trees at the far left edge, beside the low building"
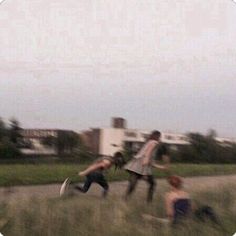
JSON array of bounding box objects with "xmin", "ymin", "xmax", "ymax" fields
[{"xmin": 0, "ymin": 118, "xmax": 21, "ymax": 158}]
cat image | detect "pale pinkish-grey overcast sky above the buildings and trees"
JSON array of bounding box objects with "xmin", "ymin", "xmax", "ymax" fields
[{"xmin": 0, "ymin": 0, "xmax": 236, "ymax": 137}]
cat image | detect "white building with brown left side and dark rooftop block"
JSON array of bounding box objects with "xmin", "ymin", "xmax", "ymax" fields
[{"xmin": 81, "ymin": 118, "xmax": 189, "ymax": 156}]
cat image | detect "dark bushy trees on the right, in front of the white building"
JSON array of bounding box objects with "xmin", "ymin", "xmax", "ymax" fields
[{"xmin": 171, "ymin": 131, "xmax": 236, "ymax": 163}]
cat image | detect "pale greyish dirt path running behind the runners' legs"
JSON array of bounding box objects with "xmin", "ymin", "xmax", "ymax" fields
[{"xmin": 0, "ymin": 175, "xmax": 236, "ymax": 201}]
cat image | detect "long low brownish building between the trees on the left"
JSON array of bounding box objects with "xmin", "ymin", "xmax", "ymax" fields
[{"xmin": 21, "ymin": 129, "xmax": 74, "ymax": 155}]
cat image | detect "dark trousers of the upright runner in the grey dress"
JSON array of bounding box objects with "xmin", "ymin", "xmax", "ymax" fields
[{"xmin": 126, "ymin": 171, "xmax": 156, "ymax": 202}]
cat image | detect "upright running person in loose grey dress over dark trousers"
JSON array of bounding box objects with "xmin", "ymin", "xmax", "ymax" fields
[{"xmin": 124, "ymin": 130, "xmax": 168, "ymax": 202}]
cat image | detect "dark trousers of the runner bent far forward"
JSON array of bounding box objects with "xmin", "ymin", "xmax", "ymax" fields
[{"xmin": 75, "ymin": 172, "xmax": 109, "ymax": 197}]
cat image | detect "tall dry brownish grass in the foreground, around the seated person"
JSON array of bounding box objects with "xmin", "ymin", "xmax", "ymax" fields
[{"xmin": 0, "ymin": 181, "xmax": 236, "ymax": 236}]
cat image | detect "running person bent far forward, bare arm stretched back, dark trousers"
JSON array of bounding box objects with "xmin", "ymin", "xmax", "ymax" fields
[{"xmin": 74, "ymin": 152, "xmax": 124, "ymax": 197}]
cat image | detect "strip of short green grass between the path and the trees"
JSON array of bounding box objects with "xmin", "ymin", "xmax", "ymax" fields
[{"xmin": 0, "ymin": 164, "xmax": 236, "ymax": 186}]
